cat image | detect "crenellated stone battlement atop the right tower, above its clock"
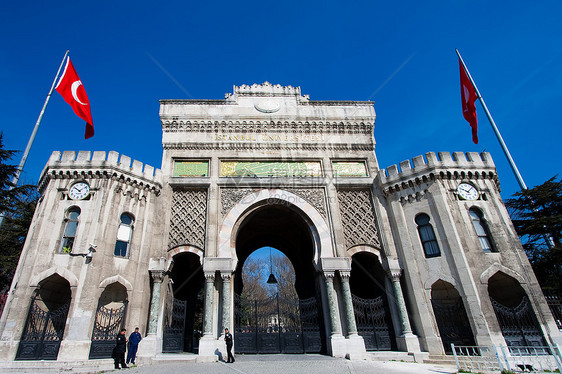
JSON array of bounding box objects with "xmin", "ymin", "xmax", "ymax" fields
[{"xmin": 379, "ymin": 152, "xmax": 497, "ymax": 187}]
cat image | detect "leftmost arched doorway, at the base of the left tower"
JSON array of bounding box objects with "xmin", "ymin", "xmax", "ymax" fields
[{"xmin": 16, "ymin": 273, "xmax": 71, "ymax": 360}]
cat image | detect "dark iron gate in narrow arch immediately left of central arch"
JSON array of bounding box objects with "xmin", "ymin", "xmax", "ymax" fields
[{"xmin": 162, "ymin": 298, "xmax": 187, "ymax": 353}]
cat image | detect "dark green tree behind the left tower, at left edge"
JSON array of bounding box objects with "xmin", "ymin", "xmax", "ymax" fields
[{"xmin": 0, "ymin": 133, "xmax": 39, "ymax": 292}]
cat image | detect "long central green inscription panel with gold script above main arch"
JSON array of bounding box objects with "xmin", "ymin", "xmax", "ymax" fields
[{"xmin": 220, "ymin": 161, "xmax": 322, "ymax": 177}]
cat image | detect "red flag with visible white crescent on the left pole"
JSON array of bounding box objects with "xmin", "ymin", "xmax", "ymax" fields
[{"xmin": 55, "ymin": 57, "xmax": 94, "ymax": 139}]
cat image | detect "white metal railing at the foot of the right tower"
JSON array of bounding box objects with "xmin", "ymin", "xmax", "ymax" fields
[{"xmin": 451, "ymin": 344, "xmax": 562, "ymax": 373}]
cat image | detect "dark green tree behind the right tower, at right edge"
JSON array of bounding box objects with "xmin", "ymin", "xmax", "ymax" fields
[{"xmin": 506, "ymin": 176, "xmax": 562, "ymax": 292}]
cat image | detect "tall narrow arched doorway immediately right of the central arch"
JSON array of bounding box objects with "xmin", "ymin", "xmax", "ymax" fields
[{"xmin": 349, "ymin": 252, "xmax": 395, "ymax": 351}]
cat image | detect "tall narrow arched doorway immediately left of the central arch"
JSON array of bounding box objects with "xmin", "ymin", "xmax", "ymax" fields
[{"xmin": 162, "ymin": 252, "xmax": 205, "ymax": 353}]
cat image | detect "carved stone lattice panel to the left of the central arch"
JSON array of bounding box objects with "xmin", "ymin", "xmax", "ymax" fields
[{"xmin": 168, "ymin": 189, "xmax": 207, "ymax": 250}]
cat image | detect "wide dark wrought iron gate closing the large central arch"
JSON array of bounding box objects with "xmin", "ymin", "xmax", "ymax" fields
[{"xmin": 234, "ymin": 294, "xmax": 322, "ymax": 353}]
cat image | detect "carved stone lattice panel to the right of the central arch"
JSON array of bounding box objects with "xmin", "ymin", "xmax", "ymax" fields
[{"xmin": 338, "ymin": 190, "xmax": 381, "ymax": 249}]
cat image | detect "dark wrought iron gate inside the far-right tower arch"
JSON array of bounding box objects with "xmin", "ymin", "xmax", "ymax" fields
[{"xmin": 490, "ymin": 296, "xmax": 547, "ymax": 347}]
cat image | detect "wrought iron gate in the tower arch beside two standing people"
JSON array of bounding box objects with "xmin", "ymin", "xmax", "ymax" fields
[{"xmin": 89, "ymin": 301, "xmax": 127, "ymax": 359}]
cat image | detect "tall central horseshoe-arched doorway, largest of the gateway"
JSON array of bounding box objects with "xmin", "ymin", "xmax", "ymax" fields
[{"xmin": 234, "ymin": 202, "xmax": 325, "ymax": 353}]
